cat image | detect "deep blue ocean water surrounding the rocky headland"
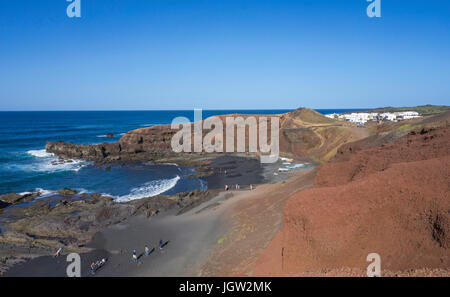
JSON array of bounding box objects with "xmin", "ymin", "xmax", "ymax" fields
[{"xmin": 0, "ymin": 109, "xmax": 362, "ymax": 201}]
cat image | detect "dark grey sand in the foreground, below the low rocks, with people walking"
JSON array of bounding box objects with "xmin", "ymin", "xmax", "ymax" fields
[{"xmin": 5, "ymin": 194, "xmax": 232, "ymax": 277}]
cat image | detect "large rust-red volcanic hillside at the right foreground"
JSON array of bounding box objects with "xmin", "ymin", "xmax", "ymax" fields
[{"xmin": 254, "ymin": 111, "xmax": 450, "ymax": 276}]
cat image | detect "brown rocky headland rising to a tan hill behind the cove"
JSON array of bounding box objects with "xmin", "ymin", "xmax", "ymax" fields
[{"xmin": 46, "ymin": 108, "xmax": 368, "ymax": 163}]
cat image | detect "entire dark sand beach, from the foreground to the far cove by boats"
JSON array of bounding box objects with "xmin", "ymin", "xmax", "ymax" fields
[{"xmin": 4, "ymin": 155, "xmax": 308, "ymax": 277}]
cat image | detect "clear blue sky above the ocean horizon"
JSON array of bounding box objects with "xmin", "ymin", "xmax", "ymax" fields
[{"xmin": 0, "ymin": 0, "xmax": 450, "ymax": 110}]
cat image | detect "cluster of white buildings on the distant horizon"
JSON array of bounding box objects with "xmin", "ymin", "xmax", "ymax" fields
[{"xmin": 326, "ymin": 111, "xmax": 421, "ymax": 125}]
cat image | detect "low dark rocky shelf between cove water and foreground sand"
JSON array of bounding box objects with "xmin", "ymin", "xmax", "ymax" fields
[{"xmin": 0, "ymin": 189, "xmax": 216, "ymax": 252}]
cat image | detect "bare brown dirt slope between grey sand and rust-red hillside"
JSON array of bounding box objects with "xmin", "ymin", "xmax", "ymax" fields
[{"xmin": 198, "ymin": 169, "xmax": 316, "ymax": 276}]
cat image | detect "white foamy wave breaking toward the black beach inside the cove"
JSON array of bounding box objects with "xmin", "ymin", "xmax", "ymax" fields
[{"xmin": 114, "ymin": 175, "xmax": 180, "ymax": 202}]
